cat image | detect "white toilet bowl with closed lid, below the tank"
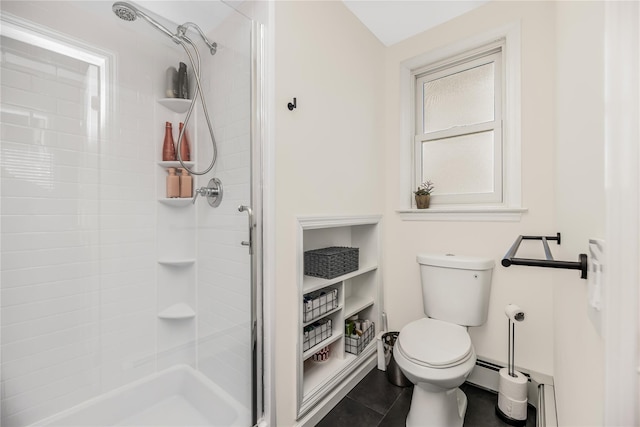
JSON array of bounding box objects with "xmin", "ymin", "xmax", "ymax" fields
[{"xmin": 393, "ymin": 318, "xmax": 476, "ymax": 427}]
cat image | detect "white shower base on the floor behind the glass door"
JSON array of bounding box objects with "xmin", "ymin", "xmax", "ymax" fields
[{"xmin": 31, "ymin": 365, "xmax": 250, "ymax": 427}]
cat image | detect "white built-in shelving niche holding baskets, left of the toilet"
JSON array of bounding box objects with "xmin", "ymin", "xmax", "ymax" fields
[{"xmin": 296, "ymin": 216, "xmax": 382, "ymax": 419}]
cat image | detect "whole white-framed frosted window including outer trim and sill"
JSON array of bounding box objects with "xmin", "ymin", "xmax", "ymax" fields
[{"xmin": 398, "ymin": 23, "xmax": 527, "ymax": 221}]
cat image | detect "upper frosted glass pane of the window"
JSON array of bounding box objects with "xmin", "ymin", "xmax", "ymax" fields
[{"xmin": 422, "ymin": 63, "xmax": 494, "ymax": 133}]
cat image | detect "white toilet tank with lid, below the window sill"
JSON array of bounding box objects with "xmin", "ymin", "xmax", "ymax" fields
[{"xmin": 417, "ymin": 254, "xmax": 495, "ymax": 326}]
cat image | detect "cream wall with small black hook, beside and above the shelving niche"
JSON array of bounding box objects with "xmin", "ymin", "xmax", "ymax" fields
[{"xmin": 272, "ymin": 1, "xmax": 384, "ymax": 426}]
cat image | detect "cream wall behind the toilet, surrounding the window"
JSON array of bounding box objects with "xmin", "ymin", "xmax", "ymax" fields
[{"xmin": 383, "ymin": 2, "xmax": 556, "ymax": 374}]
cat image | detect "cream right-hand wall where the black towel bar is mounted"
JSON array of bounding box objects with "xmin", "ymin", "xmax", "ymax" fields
[{"xmin": 553, "ymin": 2, "xmax": 605, "ymax": 426}]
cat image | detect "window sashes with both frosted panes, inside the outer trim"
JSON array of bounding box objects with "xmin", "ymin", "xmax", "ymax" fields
[{"xmin": 414, "ymin": 45, "xmax": 503, "ymax": 205}]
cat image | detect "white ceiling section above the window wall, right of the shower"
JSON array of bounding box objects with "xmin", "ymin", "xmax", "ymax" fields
[{"xmin": 343, "ymin": 0, "xmax": 489, "ymax": 46}]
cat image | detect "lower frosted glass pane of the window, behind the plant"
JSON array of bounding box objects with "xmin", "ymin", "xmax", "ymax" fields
[{"xmin": 422, "ymin": 131, "xmax": 494, "ymax": 195}]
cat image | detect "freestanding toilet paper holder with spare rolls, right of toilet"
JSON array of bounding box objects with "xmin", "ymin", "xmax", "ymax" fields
[{"xmin": 496, "ymin": 304, "xmax": 527, "ymax": 426}]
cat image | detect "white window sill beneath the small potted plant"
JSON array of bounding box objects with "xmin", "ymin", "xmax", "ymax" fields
[{"xmin": 396, "ymin": 206, "xmax": 528, "ymax": 222}]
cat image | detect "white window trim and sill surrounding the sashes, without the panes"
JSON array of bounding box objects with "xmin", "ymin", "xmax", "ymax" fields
[{"xmin": 396, "ymin": 21, "xmax": 527, "ymax": 221}]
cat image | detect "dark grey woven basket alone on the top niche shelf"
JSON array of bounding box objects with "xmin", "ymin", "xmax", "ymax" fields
[{"xmin": 304, "ymin": 246, "xmax": 359, "ymax": 279}]
